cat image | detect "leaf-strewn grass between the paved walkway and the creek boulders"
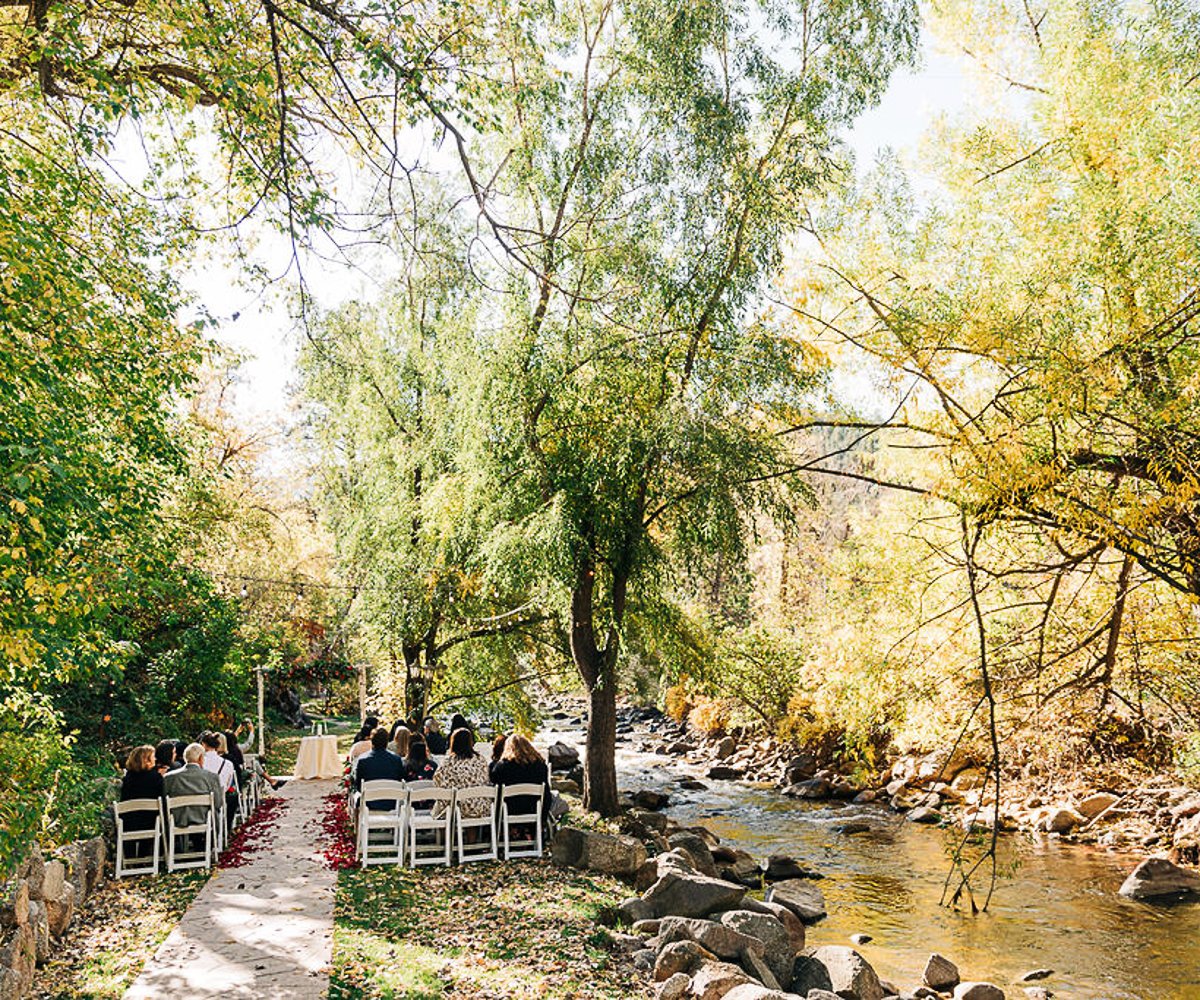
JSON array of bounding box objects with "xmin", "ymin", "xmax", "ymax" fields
[{"xmin": 329, "ymin": 861, "xmax": 653, "ymax": 1000}]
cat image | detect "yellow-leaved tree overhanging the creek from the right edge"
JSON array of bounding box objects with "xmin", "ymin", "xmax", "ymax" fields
[{"xmin": 814, "ymin": 0, "xmax": 1200, "ymax": 624}]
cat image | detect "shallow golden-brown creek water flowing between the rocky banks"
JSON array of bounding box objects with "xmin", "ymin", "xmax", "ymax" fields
[{"xmin": 547, "ymin": 732, "xmax": 1200, "ymax": 1000}]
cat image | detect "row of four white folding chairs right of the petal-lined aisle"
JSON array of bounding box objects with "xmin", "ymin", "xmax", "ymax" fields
[{"xmin": 354, "ymin": 780, "xmax": 545, "ymax": 867}]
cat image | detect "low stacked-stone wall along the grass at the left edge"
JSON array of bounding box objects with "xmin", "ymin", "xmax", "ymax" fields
[{"xmin": 0, "ymin": 837, "xmax": 108, "ymax": 1000}]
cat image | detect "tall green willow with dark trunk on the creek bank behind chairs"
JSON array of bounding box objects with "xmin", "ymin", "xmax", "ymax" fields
[{"xmin": 446, "ymin": 0, "xmax": 917, "ymax": 814}]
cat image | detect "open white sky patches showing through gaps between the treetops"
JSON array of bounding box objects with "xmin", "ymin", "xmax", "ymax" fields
[{"xmin": 204, "ymin": 36, "xmax": 968, "ymax": 423}]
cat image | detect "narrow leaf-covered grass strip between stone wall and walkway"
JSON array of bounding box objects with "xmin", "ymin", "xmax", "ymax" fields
[{"xmin": 31, "ymin": 872, "xmax": 209, "ymax": 1000}]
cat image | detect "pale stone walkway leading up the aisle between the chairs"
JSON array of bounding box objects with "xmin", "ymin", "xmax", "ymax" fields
[{"xmin": 125, "ymin": 782, "xmax": 337, "ymax": 1000}]
